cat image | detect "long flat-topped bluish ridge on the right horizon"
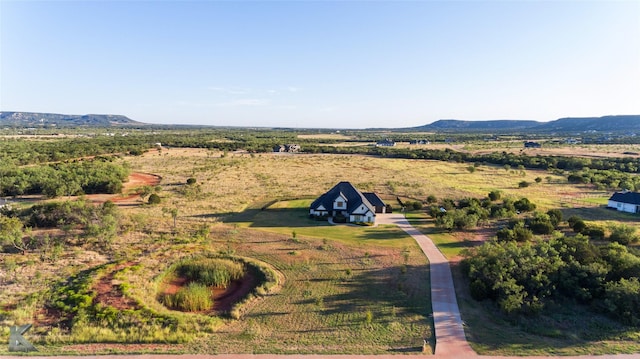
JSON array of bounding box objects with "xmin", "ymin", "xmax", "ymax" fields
[{"xmin": 410, "ymin": 115, "xmax": 640, "ymax": 133}]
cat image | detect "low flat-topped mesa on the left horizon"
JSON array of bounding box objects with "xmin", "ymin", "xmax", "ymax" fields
[{"xmin": 0, "ymin": 111, "xmax": 146, "ymax": 127}]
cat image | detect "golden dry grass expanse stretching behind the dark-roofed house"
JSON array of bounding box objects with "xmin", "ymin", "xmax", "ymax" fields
[{"xmin": 132, "ymin": 149, "xmax": 592, "ymax": 217}]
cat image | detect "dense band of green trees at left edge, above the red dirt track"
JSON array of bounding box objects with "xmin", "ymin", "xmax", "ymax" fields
[{"xmin": 0, "ymin": 157, "xmax": 129, "ymax": 198}]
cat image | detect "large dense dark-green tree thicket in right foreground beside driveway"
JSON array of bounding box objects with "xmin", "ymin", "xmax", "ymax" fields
[{"xmin": 463, "ymin": 235, "xmax": 640, "ymax": 325}]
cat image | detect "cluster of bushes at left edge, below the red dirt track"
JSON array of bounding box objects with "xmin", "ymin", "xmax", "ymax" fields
[{"xmin": 0, "ymin": 199, "xmax": 121, "ymax": 253}]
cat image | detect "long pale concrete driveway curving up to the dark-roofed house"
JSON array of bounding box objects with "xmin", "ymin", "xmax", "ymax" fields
[{"xmin": 376, "ymin": 214, "xmax": 477, "ymax": 358}]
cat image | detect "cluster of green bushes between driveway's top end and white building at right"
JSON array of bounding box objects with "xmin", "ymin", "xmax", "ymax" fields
[{"xmin": 427, "ymin": 191, "xmax": 536, "ymax": 230}]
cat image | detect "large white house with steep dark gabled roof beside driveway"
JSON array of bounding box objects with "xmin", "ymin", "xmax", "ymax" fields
[{"xmin": 309, "ymin": 182, "xmax": 386, "ymax": 224}]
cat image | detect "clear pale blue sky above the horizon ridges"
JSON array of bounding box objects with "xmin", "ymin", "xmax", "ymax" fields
[{"xmin": 0, "ymin": 0, "xmax": 640, "ymax": 128}]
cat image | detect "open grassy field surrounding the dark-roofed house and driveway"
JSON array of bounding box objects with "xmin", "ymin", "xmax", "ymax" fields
[{"xmin": 0, "ymin": 148, "xmax": 640, "ymax": 355}]
